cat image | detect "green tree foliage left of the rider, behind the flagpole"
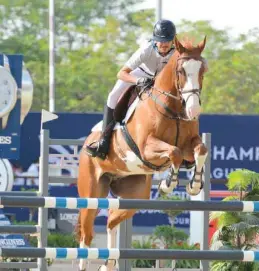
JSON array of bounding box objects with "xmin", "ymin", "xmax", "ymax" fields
[{"xmin": 0, "ymin": 0, "xmax": 154, "ymax": 112}]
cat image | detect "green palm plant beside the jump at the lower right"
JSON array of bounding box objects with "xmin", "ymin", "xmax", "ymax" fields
[{"xmin": 210, "ymin": 169, "xmax": 259, "ymax": 271}]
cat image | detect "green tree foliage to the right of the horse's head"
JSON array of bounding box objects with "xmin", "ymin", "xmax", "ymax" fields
[{"xmin": 179, "ymin": 20, "xmax": 259, "ymax": 114}]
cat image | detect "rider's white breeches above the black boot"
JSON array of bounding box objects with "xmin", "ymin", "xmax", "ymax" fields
[{"xmin": 107, "ymin": 68, "xmax": 149, "ymax": 109}]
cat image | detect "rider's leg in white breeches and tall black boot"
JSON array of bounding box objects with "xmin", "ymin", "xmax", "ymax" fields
[{"xmin": 86, "ymin": 69, "xmax": 149, "ymax": 159}]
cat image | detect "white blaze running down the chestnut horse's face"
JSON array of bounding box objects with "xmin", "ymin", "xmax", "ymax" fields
[{"xmin": 182, "ymin": 59, "xmax": 202, "ymax": 119}]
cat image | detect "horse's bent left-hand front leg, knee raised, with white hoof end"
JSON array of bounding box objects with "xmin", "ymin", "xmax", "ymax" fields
[{"xmin": 143, "ymin": 136, "xmax": 183, "ymax": 194}]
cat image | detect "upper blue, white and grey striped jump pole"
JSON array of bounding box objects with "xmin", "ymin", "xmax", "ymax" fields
[{"xmin": 0, "ymin": 196, "xmax": 259, "ymax": 212}]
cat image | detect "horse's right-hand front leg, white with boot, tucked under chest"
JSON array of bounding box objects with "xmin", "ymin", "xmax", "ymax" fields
[{"xmin": 186, "ymin": 136, "xmax": 208, "ymax": 196}]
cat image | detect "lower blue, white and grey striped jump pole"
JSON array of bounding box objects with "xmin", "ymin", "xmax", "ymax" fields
[{"xmin": 0, "ymin": 248, "xmax": 259, "ymax": 262}]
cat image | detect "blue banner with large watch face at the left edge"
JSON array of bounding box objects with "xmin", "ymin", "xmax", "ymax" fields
[{"xmin": 0, "ymin": 54, "xmax": 23, "ymax": 159}]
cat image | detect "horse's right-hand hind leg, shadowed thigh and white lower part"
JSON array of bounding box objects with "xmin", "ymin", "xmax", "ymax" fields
[{"xmin": 99, "ymin": 175, "xmax": 152, "ymax": 271}]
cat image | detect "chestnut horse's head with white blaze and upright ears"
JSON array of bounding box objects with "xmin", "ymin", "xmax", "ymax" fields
[{"xmin": 174, "ymin": 37, "xmax": 207, "ymax": 120}]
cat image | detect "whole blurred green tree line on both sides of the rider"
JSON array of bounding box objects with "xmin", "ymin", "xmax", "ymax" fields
[{"xmin": 0, "ymin": 0, "xmax": 259, "ymax": 114}]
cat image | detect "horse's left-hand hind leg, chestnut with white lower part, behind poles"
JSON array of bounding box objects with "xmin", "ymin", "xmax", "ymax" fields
[{"xmin": 77, "ymin": 156, "xmax": 109, "ymax": 271}]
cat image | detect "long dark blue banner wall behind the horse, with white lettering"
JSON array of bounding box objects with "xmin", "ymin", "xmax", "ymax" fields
[{"xmin": 7, "ymin": 113, "xmax": 259, "ymax": 232}]
